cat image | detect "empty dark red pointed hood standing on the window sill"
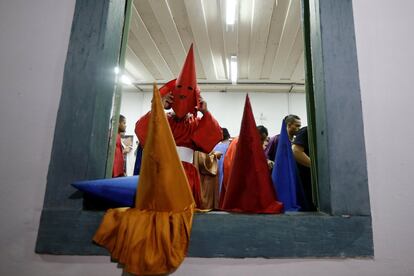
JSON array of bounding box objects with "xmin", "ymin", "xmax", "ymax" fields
[{"xmin": 221, "ymin": 95, "xmax": 283, "ymax": 214}]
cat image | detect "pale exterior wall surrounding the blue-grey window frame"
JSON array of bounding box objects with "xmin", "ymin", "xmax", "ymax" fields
[{"xmin": 0, "ymin": 0, "xmax": 414, "ymax": 276}]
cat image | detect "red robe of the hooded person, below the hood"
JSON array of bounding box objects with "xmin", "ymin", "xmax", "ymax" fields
[{"xmin": 135, "ymin": 112, "xmax": 223, "ymax": 206}]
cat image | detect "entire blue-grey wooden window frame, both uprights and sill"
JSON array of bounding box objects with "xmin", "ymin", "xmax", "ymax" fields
[{"xmin": 36, "ymin": 0, "xmax": 374, "ymax": 258}]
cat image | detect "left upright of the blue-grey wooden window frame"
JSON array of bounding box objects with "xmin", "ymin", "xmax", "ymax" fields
[{"xmin": 40, "ymin": 0, "xmax": 125, "ymax": 208}]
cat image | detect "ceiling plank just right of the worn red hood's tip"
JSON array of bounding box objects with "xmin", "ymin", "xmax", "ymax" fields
[{"xmin": 184, "ymin": 0, "xmax": 217, "ymax": 81}]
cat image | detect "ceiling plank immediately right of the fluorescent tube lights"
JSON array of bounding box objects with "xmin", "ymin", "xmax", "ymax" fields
[{"xmin": 237, "ymin": 0, "xmax": 254, "ymax": 80}]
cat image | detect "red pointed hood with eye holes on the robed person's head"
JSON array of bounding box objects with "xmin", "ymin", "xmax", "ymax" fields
[{"xmin": 160, "ymin": 45, "xmax": 200, "ymax": 118}]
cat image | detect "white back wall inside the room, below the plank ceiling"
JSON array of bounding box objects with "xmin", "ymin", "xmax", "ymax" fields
[{"xmin": 121, "ymin": 92, "xmax": 307, "ymax": 136}]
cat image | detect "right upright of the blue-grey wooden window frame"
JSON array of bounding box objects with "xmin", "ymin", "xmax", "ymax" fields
[{"xmin": 309, "ymin": 0, "xmax": 371, "ymax": 215}]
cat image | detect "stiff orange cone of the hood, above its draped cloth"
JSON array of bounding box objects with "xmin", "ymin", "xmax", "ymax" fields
[{"xmin": 135, "ymin": 84, "xmax": 194, "ymax": 212}]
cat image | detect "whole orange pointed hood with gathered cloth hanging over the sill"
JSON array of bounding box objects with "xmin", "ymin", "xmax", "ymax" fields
[{"xmin": 93, "ymin": 85, "xmax": 195, "ymax": 275}]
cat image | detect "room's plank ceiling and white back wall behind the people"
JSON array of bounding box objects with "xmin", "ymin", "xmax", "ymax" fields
[{"xmin": 118, "ymin": 0, "xmax": 307, "ymax": 175}]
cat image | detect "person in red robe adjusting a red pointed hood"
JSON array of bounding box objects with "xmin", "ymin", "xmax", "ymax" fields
[{"xmin": 135, "ymin": 45, "xmax": 222, "ymax": 207}]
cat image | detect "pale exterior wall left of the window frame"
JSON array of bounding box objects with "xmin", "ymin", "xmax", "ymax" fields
[{"xmin": 0, "ymin": 0, "xmax": 120, "ymax": 276}]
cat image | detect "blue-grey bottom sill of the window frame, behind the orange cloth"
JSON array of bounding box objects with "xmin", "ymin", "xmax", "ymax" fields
[{"xmin": 36, "ymin": 210, "xmax": 373, "ymax": 258}]
